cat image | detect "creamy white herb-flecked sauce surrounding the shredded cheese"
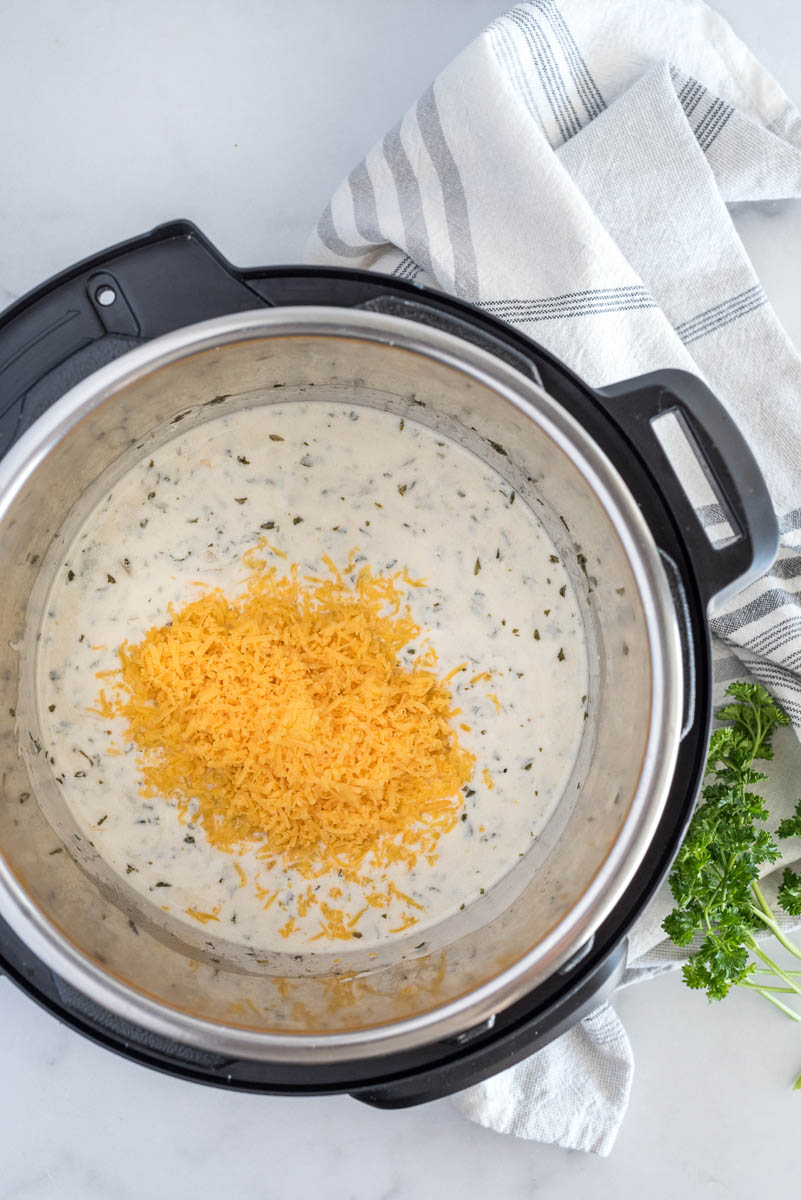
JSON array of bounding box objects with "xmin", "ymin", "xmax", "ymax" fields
[{"xmin": 37, "ymin": 403, "xmax": 588, "ymax": 953}]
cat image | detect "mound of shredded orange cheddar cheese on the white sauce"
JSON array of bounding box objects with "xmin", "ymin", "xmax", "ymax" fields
[{"xmin": 98, "ymin": 549, "xmax": 475, "ymax": 877}]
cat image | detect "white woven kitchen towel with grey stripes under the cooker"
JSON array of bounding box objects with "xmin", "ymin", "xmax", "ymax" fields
[{"xmin": 308, "ymin": 0, "xmax": 801, "ymax": 1154}]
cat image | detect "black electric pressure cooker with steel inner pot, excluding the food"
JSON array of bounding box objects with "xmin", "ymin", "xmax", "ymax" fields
[{"xmin": 0, "ymin": 222, "xmax": 777, "ymax": 1108}]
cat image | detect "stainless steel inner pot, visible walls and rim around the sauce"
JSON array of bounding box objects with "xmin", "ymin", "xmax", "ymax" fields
[{"xmin": 0, "ymin": 307, "xmax": 682, "ymax": 1063}]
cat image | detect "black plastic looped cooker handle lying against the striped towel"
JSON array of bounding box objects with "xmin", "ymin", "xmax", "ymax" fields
[{"xmin": 595, "ymin": 370, "xmax": 778, "ymax": 606}]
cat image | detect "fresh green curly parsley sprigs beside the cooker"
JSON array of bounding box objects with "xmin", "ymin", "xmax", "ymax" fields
[{"xmin": 662, "ymin": 683, "xmax": 801, "ymax": 1088}]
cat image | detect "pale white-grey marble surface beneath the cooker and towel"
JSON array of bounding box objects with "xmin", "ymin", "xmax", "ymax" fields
[{"xmin": 0, "ymin": 0, "xmax": 801, "ymax": 1200}]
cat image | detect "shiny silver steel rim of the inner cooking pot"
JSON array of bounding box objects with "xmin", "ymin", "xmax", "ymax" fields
[{"xmin": 0, "ymin": 307, "xmax": 682, "ymax": 1064}]
